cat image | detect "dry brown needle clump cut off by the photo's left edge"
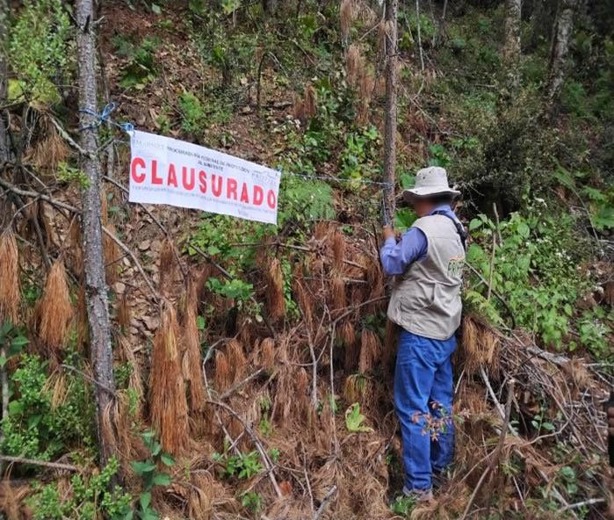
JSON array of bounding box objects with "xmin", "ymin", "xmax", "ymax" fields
[{"xmin": 0, "ymin": 230, "xmax": 21, "ymax": 323}]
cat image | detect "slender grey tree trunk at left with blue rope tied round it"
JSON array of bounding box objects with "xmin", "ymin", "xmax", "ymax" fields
[{"xmin": 77, "ymin": 0, "xmax": 115, "ymax": 467}]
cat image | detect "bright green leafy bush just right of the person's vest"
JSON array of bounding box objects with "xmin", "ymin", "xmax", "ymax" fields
[{"xmin": 465, "ymin": 203, "xmax": 591, "ymax": 348}]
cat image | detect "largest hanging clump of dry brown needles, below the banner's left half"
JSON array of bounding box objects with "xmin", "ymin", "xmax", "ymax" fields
[{"xmin": 149, "ymin": 302, "xmax": 189, "ymax": 454}]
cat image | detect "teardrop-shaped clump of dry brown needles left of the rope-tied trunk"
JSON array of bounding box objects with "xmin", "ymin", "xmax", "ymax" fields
[{"xmin": 36, "ymin": 260, "xmax": 74, "ymax": 356}]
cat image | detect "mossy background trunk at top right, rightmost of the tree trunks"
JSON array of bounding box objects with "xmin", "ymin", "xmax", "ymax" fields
[{"xmin": 547, "ymin": 0, "xmax": 578, "ymax": 103}]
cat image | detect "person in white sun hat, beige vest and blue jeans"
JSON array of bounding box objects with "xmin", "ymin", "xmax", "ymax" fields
[{"xmin": 380, "ymin": 167, "xmax": 466, "ymax": 502}]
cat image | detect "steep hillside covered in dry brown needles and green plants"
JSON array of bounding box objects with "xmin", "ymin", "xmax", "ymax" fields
[{"xmin": 0, "ymin": 0, "xmax": 614, "ymax": 520}]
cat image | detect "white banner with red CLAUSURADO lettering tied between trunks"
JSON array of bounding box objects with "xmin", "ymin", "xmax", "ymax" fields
[{"xmin": 129, "ymin": 131, "xmax": 280, "ymax": 224}]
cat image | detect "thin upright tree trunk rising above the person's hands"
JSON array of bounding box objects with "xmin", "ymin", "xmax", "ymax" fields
[{"xmin": 384, "ymin": 0, "xmax": 399, "ymax": 224}]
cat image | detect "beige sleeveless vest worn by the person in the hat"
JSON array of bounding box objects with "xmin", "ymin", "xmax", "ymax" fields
[{"xmin": 388, "ymin": 215, "xmax": 465, "ymax": 340}]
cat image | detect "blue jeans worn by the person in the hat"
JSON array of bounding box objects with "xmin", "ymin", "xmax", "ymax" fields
[{"xmin": 394, "ymin": 330, "xmax": 456, "ymax": 490}]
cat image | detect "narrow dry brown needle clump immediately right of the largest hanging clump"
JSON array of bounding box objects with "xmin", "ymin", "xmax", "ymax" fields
[{"xmin": 182, "ymin": 303, "xmax": 205, "ymax": 413}]
